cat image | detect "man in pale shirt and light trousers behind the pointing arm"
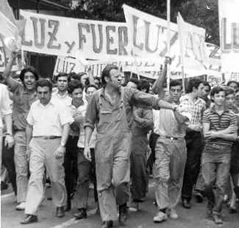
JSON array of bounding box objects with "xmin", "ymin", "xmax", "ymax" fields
[{"xmin": 154, "ymin": 80, "xmax": 191, "ymax": 223}]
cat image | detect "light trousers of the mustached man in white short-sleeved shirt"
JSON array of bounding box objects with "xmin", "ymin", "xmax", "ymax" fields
[{"xmin": 25, "ymin": 138, "xmax": 67, "ymax": 215}]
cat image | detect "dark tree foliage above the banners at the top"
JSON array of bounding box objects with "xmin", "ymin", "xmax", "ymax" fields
[{"xmin": 69, "ymin": 0, "xmax": 219, "ymax": 44}]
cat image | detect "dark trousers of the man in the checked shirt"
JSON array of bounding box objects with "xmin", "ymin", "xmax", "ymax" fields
[{"xmin": 182, "ymin": 131, "xmax": 203, "ymax": 200}]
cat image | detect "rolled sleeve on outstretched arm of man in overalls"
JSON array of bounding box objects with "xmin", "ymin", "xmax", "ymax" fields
[{"xmin": 125, "ymin": 88, "xmax": 160, "ymax": 109}]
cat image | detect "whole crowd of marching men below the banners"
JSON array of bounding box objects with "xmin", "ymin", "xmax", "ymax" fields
[{"xmin": 0, "ymin": 54, "xmax": 239, "ymax": 228}]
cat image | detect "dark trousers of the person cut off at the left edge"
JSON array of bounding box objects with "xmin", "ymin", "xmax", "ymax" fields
[{"xmin": 2, "ymin": 137, "xmax": 17, "ymax": 195}]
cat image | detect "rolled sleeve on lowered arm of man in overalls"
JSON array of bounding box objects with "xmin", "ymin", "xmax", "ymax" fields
[{"xmin": 84, "ymin": 93, "xmax": 99, "ymax": 129}]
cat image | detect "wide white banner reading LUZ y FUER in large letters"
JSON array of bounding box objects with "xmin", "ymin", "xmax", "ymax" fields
[{"xmin": 20, "ymin": 10, "xmax": 129, "ymax": 59}]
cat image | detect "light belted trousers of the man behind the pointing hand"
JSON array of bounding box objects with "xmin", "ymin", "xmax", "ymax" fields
[{"xmin": 154, "ymin": 137, "xmax": 186, "ymax": 209}]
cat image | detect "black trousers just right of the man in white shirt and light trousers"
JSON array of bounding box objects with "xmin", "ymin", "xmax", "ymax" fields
[{"xmin": 64, "ymin": 136, "xmax": 79, "ymax": 203}]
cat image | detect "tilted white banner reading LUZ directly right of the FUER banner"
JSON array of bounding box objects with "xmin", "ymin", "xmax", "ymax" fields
[{"xmin": 123, "ymin": 5, "xmax": 180, "ymax": 67}]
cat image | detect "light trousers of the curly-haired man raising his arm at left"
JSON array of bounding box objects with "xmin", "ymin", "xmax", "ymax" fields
[{"xmin": 14, "ymin": 131, "xmax": 28, "ymax": 203}]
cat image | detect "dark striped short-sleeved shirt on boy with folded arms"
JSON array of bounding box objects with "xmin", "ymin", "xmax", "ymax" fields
[{"xmin": 203, "ymin": 106, "xmax": 237, "ymax": 146}]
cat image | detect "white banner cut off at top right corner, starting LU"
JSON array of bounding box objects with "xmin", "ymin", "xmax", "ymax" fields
[{"xmin": 219, "ymin": 0, "xmax": 239, "ymax": 73}]
